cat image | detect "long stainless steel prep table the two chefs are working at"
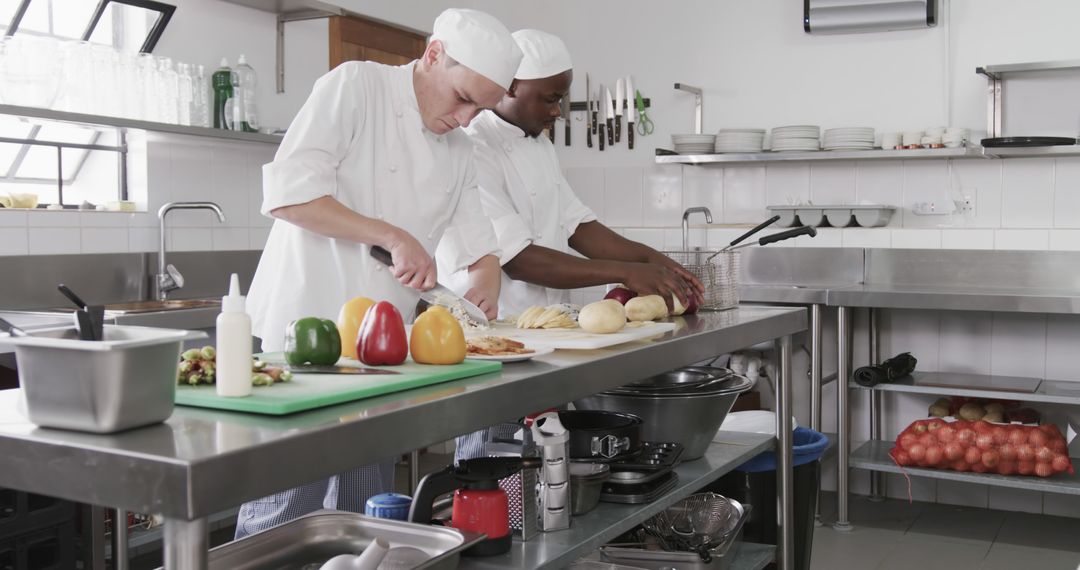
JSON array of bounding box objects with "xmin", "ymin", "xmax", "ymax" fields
[{"xmin": 0, "ymin": 307, "xmax": 807, "ymax": 570}]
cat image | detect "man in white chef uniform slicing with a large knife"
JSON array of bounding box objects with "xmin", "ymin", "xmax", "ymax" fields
[{"xmin": 237, "ymin": 10, "xmax": 522, "ymax": 538}]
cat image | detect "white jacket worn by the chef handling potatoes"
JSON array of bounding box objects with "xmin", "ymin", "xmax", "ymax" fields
[{"xmin": 437, "ymin": 111, "xmax": 596, "ymax": 316}]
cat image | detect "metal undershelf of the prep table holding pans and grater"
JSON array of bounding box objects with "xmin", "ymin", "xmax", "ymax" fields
[{"xmin": 459, "ymin": 432, "xmax": 775, "ymax": 570}]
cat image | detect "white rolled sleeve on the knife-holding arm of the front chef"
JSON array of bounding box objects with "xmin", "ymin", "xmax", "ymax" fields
[{"xmin": 261, "ymin": 64, "xmax": 367, "ymax": 216}]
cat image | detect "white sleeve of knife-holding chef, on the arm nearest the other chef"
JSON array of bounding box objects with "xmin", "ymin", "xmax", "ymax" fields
[{"xmin": 440, "ymin": 154, "xmax": 499, "ymax": 271}]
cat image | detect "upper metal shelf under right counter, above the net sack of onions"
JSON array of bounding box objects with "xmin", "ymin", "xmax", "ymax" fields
[{"xmin": 848, "ymin": 372, "xmax": 1080, "ymax": 405}]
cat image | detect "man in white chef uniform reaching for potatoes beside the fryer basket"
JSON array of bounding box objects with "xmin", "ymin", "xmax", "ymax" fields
[{"xmin": 437, "ymin": 29, "xmax": 704, "ymax": 459}]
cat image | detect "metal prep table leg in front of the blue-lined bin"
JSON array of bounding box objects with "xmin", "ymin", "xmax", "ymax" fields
[{"xmin": 777, "ymin": 335, "xmax": 795, "ymax": 570}]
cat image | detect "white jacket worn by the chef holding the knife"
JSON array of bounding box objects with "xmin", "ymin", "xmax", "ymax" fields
[{"xmin": 247, "ymin": 62, "xmax": 498, "ymax": 351}]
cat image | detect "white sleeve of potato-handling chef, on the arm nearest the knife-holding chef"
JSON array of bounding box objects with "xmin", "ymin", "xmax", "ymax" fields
[{"xmin": 474, "ymin": 146, "xmax": 532, "ymax": 266}]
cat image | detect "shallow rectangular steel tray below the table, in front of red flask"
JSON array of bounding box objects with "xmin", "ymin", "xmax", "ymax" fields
[{"xmin": 183, "ymin": 511, "xmax": 483, "ymax": 570}]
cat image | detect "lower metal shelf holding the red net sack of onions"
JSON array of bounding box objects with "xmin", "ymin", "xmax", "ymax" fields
[{"xmin": 851, "ymin": 440, "xmax": 1080, "ymax": 494}]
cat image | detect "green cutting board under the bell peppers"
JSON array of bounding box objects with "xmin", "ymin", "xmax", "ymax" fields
[{"xmin": 176, "ymin": 353, "xmax": 502, "ymax": 416}]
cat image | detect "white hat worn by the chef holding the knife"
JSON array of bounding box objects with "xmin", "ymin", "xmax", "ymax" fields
[{"xmin": 431, "ymin": 8, "xmax": 522, "ymax": 89}]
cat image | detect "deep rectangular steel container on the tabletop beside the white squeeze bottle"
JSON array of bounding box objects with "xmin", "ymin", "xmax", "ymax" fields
[{"xmin": 0, "ymin": 325, "xmax": 206, "ymax": 433}]
